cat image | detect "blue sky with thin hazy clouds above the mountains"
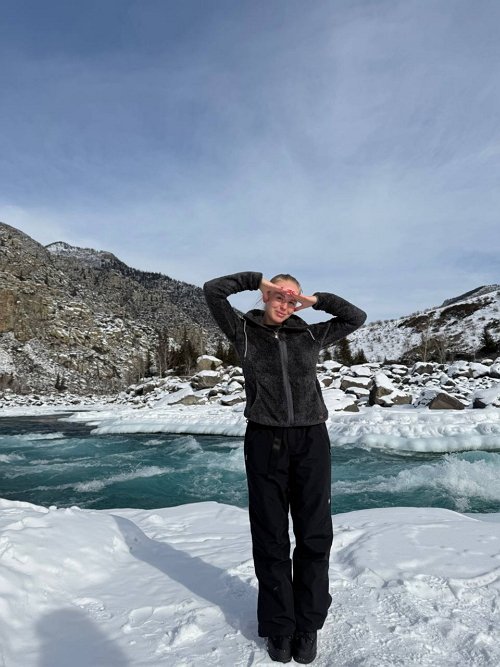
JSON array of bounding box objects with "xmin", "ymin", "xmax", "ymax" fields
[{"xmin": 0, "ymin": 0, "xmax": 500, "ymax": 321}]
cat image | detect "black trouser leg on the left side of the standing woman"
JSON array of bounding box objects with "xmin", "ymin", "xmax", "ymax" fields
[{"xmin": 245, "ymin": 422, "xmax": 295, "ymax": 637}]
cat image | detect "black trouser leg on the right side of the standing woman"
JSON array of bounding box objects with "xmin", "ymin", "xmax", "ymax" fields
[{"xmin": 288, "ymin": 424, "xmax": 333, "ymax": 632}]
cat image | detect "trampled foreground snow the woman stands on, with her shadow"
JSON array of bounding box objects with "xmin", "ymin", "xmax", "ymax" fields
[{"xmin": 0, "ymin": 500, "xmax": 500, "ymax": 667}]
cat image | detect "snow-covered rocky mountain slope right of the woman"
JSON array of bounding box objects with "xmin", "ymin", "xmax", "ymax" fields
[{"xmin": 349, "ymin": 285, "xmax": 500, "ymax": 364}]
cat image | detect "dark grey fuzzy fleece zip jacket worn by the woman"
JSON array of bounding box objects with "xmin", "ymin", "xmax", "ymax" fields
[{"xmin": 203, "ymin": 271, "xmax": 366, "ymax": 426}]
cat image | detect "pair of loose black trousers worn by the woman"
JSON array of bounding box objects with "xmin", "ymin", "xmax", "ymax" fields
[{"xmin": 245, "ymin": 422, "xmax": 333, "ymax": 637}]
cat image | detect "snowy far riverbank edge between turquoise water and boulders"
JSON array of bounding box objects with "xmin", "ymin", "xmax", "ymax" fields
[{"xmin": 0, "ymin": 400, "xmax": 500, "ymax": 453}]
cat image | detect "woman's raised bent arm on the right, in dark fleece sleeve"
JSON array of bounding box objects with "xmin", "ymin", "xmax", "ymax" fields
[{"xmin": 309, "ymin": 292, "xmax": 366, "ymax": 347}]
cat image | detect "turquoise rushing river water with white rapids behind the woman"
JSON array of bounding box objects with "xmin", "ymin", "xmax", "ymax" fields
[{"xmin": 0, "ymin": 415, "xmax": 500, "ymax": 514}]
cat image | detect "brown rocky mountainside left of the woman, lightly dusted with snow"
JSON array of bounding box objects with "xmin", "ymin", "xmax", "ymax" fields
[{"xmin": 0, "ymin": 223, "xmax": 218, "ymax": 393}]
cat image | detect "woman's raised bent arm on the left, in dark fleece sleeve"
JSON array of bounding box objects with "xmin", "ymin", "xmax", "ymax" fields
[{"xmin": 203, "ymin": 271, "xmax": 262, "ymax": 341}]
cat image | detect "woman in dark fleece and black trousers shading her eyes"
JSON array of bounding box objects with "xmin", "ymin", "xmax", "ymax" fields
[{"xmin": 203, "ymin": 271, "xmax": 366, "ymax": 664}]
